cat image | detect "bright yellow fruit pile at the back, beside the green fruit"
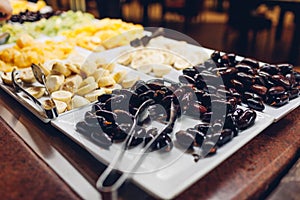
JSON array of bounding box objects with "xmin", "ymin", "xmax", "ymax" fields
[{"xmin": 62, "ymin": 18, "xmax": 144, "ymax": 51}]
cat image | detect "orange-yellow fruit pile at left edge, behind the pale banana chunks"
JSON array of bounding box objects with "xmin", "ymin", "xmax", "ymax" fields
[{"xmin": 0, "ymin": 35, "xmax": 74, "ymax": 72}]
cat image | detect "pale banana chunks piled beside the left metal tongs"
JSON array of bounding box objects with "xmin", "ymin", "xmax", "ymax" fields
[{"xmin": 1, "ymin": 55, "xmax": 139, "ymax": 113}]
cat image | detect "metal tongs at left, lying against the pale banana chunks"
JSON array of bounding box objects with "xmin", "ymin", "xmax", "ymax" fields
[{"xmin": 11, "ymin": 69, "xmax": 58, "ymax": 119}]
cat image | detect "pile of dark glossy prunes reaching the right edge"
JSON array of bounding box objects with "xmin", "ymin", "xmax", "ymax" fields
[{"xmin": 210, "ymin": 51, "xmax": 300, "ymax": 111}]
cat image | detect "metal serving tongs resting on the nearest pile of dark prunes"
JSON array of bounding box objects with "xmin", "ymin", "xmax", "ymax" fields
[{"xmin": 96, "ymin": 99, "xmax": 176, "ymax": 195}]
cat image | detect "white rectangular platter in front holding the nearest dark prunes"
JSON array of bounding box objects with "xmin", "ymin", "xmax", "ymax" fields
[{"xmin": 51, "ymin": 102, "xmax": 274, "ymax": 199}]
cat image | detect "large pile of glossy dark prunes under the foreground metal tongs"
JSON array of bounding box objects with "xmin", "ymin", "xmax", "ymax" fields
[{"xmin": 76, "ymin": 72, "xmax": 256, "ymax": 159}]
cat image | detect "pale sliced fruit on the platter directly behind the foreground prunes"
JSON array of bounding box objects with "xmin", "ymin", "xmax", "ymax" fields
[{"xmin": 117, "ymin": 37, "xmax": 209, "ymax": 77}]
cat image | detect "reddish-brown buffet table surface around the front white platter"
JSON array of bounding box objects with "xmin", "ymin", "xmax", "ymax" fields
[{"xmin": 0, "ymin": 75, "xmax": 300, "ymax": 199}]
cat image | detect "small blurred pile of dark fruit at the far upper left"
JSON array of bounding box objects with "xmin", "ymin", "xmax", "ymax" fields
[{"xmin": 9, "ymin": 10, "xmax": 62, "ymax": 24}]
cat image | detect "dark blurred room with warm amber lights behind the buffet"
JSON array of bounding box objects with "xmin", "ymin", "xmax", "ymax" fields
[{"xmin": 47, "ymin": 0, "xmax": 300, "ymax": 66}]
